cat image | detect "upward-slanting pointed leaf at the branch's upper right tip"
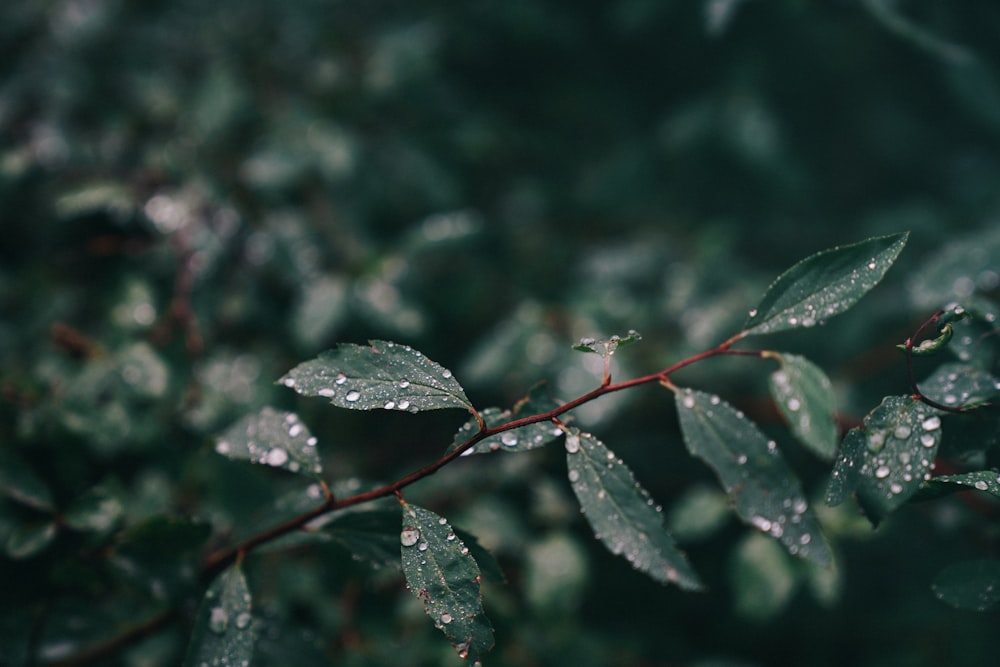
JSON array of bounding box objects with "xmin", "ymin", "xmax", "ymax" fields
[{"xmin": 742, "ymin": 233, "xmax": 908, "ymax": 336}]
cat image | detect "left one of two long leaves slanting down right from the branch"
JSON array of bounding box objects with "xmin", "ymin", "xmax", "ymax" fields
[{"xmin": 566, "ymin": 428, "xmax": 702, "ymax": 590}]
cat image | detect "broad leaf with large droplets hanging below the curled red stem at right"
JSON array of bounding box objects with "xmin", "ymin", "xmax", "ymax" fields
[{"xmin": 828, "ymin": 396, "xmax": 941, "ymax": 523}]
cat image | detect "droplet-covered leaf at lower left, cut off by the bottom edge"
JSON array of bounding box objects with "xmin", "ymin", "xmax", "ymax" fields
[{"xmin": 184, "ymin": 565, "xmax": 254, "ymax": 667}]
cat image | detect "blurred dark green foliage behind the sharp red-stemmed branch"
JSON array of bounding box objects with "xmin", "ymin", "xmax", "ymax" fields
[{"xmin": 0, "ymin": 0, "xmax": 1000, "ymax": 667}]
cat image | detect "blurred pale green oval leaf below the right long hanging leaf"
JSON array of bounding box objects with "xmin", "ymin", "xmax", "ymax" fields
[{"xmin": 730, "ymin": 534, "xmax": 797, "ymax": 621}]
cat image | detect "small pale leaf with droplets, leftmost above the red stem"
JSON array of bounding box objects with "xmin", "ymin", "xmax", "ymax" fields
[{"xmin": 215, "ymin": 407, "xmax": 323, "ymax": 475}]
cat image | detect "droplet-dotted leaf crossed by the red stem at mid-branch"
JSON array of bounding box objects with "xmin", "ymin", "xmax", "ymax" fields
[{"xmin": 449, "ymin": 384, "xmax": 562, "ymax": 454}]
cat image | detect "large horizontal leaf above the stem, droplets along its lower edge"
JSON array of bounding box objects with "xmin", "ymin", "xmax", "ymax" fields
[{"xmin": 279, "ymin": 340, "xmax": 473, "ymax": 412}]
